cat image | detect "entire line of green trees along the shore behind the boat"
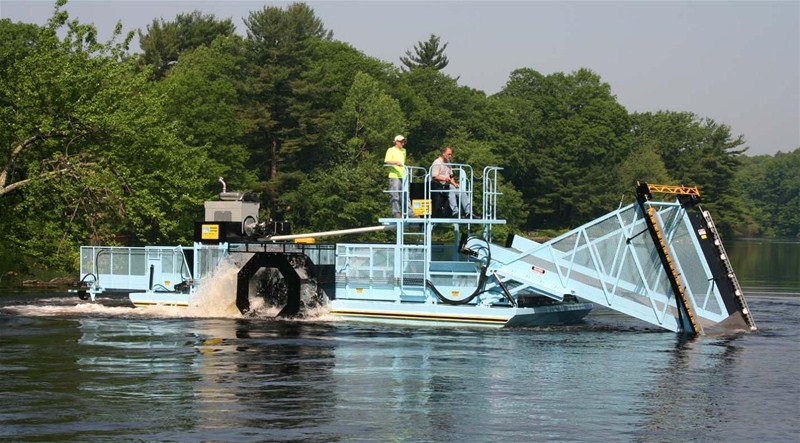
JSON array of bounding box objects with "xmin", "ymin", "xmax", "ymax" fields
[{"xmin": 0, "ymin": 0, "xmax": 800, "ymax": 278}]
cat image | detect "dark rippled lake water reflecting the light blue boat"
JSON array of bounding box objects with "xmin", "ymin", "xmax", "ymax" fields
[{"xmin": 0, "ymin": 240, "xmax": 800, "ymax": 442}]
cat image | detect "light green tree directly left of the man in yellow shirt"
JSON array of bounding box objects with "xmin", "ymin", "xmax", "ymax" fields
[{"xmin": 278, "ymin": 72, "xmax": 406, "ymax": 229}]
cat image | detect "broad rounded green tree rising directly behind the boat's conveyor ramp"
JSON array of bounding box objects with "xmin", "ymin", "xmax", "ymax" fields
[{"xmin": 497, "ymin": 69, "xmax": 630, "ymax": 228}]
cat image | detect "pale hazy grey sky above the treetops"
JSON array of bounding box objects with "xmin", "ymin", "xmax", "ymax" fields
[{"xmin": 0, "ymin": 0, "xmax": 800, "ymax": 155}]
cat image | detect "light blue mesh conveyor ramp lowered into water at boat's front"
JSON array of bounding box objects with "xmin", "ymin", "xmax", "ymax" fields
[{"xmin": 482, "ymin": 184, "xmax": 756, "ymax": 334}]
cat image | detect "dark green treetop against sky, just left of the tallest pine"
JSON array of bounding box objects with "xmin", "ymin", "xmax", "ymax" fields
[{"xmin": 139, "ymin": 11, "xmax": 235, "ymax": 80}]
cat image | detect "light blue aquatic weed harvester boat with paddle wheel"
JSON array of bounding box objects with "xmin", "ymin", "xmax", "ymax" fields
[{"xmin": 79, "ymin": 164, "xmax": 756, "ymax": 334}]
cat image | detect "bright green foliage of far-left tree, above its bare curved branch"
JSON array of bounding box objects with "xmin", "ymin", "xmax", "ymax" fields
[{"xmin": 0, "ymin": 3, "xmax": 134, "ymax": 200}]
